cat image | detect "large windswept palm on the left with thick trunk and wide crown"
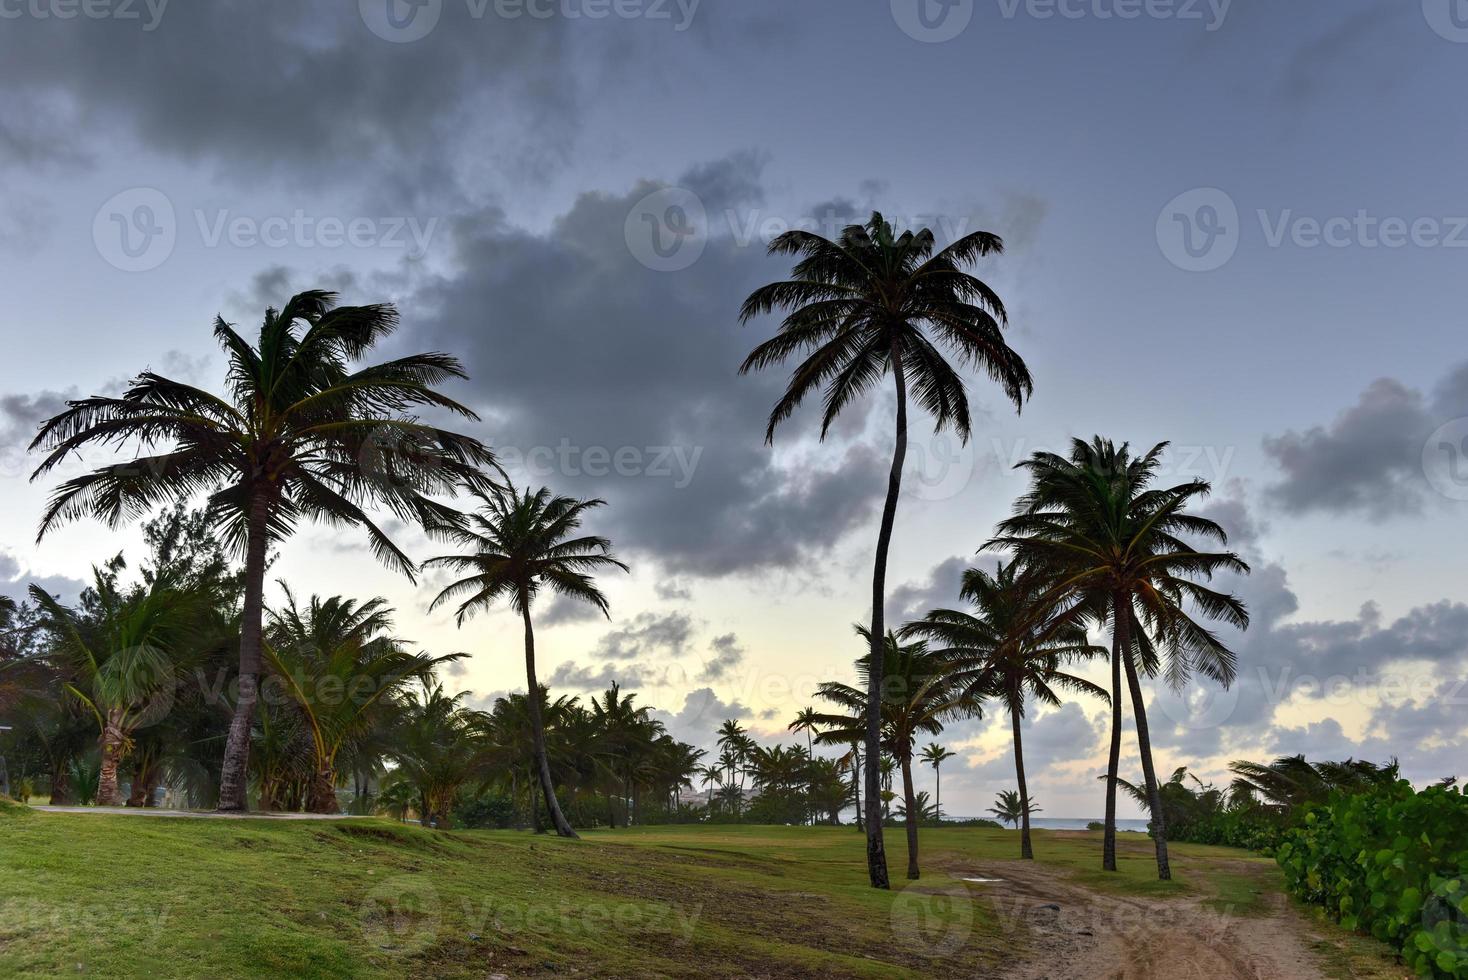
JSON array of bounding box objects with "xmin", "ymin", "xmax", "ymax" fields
[{"xmin": 31, "ymin": 290, "xmax": 495, "ymax": 811}]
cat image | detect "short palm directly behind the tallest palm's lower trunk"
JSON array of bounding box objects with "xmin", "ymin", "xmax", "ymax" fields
[{"xmin": 816, "ymin": 626, "xmax": 979, "ymax": 880}]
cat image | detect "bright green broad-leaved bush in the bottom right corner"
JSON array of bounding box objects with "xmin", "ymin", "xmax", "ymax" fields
[{"xmin": 1277, "ymin": 782, "xmax": 1468, "ymax": 979}]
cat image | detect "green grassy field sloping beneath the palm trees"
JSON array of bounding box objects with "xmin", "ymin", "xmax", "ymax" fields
[{"xmin": 0, "ymin": 808, "xmax": 1397, "ymax": 977}]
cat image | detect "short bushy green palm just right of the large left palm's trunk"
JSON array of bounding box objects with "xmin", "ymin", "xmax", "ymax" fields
[{"xmin": 264, "ymin": 582, "xmax": 465, "ymax": 813}]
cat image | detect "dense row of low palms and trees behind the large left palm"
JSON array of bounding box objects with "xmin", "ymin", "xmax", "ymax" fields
[{"xmin": 0, "ymin": 506, "xmax": 703, "ymax": 827}]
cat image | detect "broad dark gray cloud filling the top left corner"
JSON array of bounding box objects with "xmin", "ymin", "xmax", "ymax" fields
[{"xmin": 0, "ymin": 0, "xmax": 584, "ymax": 199}]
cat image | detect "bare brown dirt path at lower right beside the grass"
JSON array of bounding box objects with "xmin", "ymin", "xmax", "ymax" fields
[{"xmin": 954, "ymin": 861, "xmax": 1326, "ymax": 980}]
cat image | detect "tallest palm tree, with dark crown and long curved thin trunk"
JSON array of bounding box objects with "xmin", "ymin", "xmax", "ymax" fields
[{"xmin": 740, "ymin": 213, "xmax": 1032, "ymax": 888}]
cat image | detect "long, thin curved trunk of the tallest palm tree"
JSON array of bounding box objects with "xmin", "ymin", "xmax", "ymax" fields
[{"xmin": 866, "ymin": 346, "xmax": 907, "ymax": 888}]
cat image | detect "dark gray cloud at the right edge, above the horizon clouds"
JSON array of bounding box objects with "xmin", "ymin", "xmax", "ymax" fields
[{"xmin": 1264, "ymin": 365, "xmax": 1468, "ymax": 521}]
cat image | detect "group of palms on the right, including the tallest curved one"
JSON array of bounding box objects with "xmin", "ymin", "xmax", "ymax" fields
[{"xmin": 741, "ymin": 213, "xmax": 1248, "ymax": 888}]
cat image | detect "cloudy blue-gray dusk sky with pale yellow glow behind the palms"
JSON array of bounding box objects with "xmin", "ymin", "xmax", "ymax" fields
[{"xmin": 0, "ymin": 0, "xmax": 1468, "ymax": 817}]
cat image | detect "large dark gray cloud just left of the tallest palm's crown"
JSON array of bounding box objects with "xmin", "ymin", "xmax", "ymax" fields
[{"xmin": 405, "ymin": 154, "xmax": 885, "ymax": 575}]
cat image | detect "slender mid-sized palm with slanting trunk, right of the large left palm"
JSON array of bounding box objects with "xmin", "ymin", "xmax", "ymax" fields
[{"xmin": 424, "ymin": 487, "xmax": 627, "ymax": 838}]
